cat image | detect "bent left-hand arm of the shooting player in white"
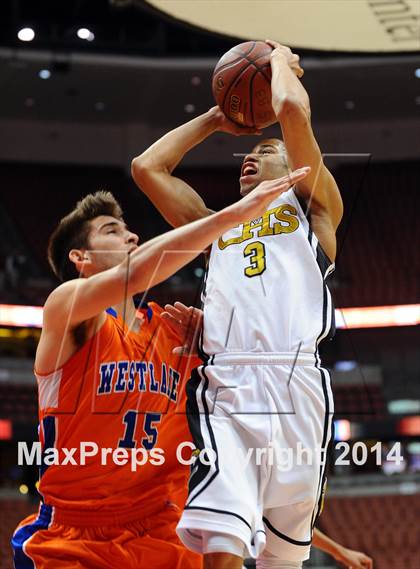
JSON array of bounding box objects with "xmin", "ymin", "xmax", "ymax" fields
[{"xmin": 131, "ymin": 107, "xmax": 260, "ymax": 227}]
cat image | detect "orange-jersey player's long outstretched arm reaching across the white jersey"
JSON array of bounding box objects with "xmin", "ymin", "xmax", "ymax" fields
[{"xmin": 44, "ymin": 169, "xmax": 308, "ymax": 327}]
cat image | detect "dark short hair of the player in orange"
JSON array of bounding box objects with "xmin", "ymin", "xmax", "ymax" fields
[{"xmin": 48, "ymin": 191, "xmax": 122, "ymax": 281}]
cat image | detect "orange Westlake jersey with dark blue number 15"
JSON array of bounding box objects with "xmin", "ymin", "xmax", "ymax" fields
[{"xmin": 37, "ymin": 303, "xmax": 199, "ymax": 513}]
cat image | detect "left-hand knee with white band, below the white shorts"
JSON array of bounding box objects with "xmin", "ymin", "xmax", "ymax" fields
[{"xmin": 202, "ymin": 531, "xmax": 245, "ymax": 569}]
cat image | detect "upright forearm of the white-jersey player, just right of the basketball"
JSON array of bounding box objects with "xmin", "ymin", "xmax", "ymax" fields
[{"xmin": 271, "ymin": 54, "xmax": 310, "ymax": 118}]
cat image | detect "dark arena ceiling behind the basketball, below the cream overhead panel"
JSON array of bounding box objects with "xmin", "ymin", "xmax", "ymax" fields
[{"xmin": 0, "ymin": 0, "xmax": 420, "ymax": 164}]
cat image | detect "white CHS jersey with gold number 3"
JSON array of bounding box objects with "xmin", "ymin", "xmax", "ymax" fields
[{"xmin": 201, "ymin": 188, "xmax": 334, "ymax": 357}]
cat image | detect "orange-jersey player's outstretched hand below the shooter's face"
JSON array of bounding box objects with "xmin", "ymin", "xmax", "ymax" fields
[{"xmin": 235, "ymin": 166, "xmax": 311, "ymax": 224}]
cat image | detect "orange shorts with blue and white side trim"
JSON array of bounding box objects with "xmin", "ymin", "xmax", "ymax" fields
[{"xmin": 12, "ymin": 502, "xmax": 202, "ymax": 569}]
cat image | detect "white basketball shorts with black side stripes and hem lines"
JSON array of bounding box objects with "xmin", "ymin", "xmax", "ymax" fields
[{"xmin": 177, "ymin": 353, "xmax": 333, "ymax": 562}]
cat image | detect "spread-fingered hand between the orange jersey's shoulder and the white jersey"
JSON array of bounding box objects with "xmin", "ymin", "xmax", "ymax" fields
[{"xmin": 161, "ymin": 302, "xmax": 203, "ymax": 356}]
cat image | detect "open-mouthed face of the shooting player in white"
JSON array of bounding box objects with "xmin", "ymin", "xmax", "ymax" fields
[{"xmin": 239, "ymin": 138, "xmax": 290, "ymax": 196}]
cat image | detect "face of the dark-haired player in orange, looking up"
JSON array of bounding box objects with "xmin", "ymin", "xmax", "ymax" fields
[{"xmin": 70, "ymin": 215, "xmax": 139, "ymax": 276}]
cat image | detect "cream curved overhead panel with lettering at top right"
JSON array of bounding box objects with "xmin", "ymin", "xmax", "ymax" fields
[{"xmin": 148, "ymin": 0, "xmax": 420, "ymax": 53}]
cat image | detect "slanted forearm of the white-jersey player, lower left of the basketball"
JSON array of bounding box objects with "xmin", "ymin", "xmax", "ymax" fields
[{"xmin": 133, "ymin": 108, "xmax": 218, "ymax": 173}]
